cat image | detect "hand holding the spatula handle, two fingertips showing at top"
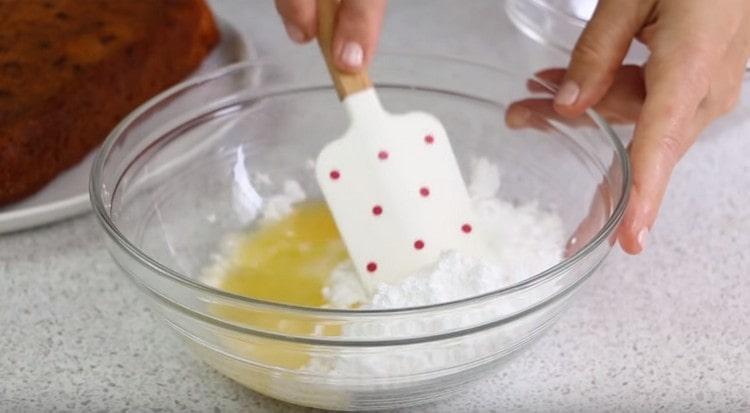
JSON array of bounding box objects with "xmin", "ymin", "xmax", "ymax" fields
[{"xmin": 276, "ymin": 0, "xmax": 386, "ymax": 73}]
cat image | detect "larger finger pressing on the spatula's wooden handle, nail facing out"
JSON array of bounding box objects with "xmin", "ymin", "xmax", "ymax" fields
[{"xmin": 333, "ymin": 0, "xmax": 386, "ymax": 73}]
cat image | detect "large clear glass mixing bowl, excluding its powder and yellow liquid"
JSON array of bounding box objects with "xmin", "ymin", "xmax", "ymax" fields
[{"xmin": 91, "ymin": 55, "xmax": 630, "ymax": 410}]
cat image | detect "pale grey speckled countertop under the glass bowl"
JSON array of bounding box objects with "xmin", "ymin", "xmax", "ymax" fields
[{"xmin": 0, "ymin": 0, "xmax": 750, "ymax": 412}]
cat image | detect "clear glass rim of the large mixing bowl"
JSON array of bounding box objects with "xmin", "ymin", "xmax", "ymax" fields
[{"xmin": 89, "ymin": 53, "xmax": 631, "ymax": 318}]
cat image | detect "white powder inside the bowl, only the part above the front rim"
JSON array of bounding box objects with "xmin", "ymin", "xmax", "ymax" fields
[{"xmin": 323, "ymin": 159, "xmax": 564, "ymax": 309}]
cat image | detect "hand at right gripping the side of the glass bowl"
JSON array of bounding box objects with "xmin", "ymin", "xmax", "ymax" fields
[{"xmin": 554, "ymin": 0, "xmax": 750, "ymax": 254}]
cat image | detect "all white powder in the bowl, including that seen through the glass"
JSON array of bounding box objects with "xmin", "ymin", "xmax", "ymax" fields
[{"xmin": 302, "ymin": 159, "xmax": 565, "ymax": 380}]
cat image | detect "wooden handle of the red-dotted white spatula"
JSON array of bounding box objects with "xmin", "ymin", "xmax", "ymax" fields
[{"xmin": 317, "ymin": 0, "xmax": 372, "ymax": 100}]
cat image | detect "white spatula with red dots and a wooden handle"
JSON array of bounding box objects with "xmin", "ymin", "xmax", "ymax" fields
[{"xmin": 316, "ymin": 0, "xmax": 482, "ymax": 285}]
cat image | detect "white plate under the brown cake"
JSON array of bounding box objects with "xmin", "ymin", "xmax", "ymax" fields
[{"xmin": 0, "ymin": 19, "xmax": 255, "ymax": 234}]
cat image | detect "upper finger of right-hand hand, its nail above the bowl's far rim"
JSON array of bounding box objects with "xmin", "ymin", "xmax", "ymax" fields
[{"xmin": 555, "ymin": 0, "xmax": 648, "ymax": 117}]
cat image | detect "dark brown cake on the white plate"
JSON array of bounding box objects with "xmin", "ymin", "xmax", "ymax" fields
[{"xmin": 0, "ymin": 0, "xmax": 219, "ymax": 205}]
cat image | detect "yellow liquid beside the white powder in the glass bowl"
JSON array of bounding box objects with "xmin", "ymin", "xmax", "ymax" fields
[{"xmin": 214, "ymin": 202, "xmax": 348, "ymax": 369}]
